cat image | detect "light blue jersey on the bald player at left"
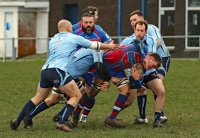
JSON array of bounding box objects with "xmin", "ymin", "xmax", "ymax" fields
[{"xmin": 42, "ymin": 32, "xmax": 92, "ymax": 72}]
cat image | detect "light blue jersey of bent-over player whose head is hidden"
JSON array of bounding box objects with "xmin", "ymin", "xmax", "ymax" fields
[{"xmin": 67, "ymin": 48, "xmax": 103, "ymax": 79}]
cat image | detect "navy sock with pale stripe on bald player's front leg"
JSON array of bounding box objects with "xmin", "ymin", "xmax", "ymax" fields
[{"xmin": 59, "ymin": 104, "xmax": 74, "ymax": 124}]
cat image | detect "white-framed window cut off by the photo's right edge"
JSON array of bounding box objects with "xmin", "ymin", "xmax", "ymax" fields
[{"xmin": 185, "ymin": 0, "xmax": 200, "ymax": 49}]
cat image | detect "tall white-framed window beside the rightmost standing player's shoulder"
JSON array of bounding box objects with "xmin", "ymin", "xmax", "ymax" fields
[{"xmin": 158, "ymin": 0, "xmax": 175, "ymax": 46}]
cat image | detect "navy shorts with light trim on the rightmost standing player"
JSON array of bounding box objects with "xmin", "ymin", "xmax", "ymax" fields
[{"xmin": 157, "ymin": 57, "xmax": 170, "ymax": 77}]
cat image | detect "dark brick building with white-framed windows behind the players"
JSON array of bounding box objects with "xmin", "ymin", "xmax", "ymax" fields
[{"xmin": 49, "ymin": 0, "xmax": 200, "ymax": 58}]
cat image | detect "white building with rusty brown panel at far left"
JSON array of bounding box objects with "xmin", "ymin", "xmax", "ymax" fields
[{"xmin": 0, "ymin": 0, "xmax": 49, "ymax": 57}]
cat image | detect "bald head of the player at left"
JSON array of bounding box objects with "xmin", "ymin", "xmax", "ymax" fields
[{"xmin": 58, "ymin": 19, "xmax": 72, "ymax": 32}]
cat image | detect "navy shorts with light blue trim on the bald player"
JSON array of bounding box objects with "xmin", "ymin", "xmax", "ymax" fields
[{"xmin": 38, "ymin": 68, "xmax": 73, "ymax": 88}]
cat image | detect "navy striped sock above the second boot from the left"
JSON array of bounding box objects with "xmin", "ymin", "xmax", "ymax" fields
[{"xmin": 26, "ymin": 101, "xmax": 49, "ymax": 118}]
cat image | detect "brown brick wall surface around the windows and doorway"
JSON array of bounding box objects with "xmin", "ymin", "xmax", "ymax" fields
[{"xmin": 49, "ymin": 0, "xmax": 198, "ymax": 58}]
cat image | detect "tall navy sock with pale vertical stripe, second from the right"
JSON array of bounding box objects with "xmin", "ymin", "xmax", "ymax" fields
[{"xmin": 137, "ymin": 94, "xmax": 147, "ymax": 119}]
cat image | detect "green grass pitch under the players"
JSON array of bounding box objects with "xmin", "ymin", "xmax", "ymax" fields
[{"xmin": 0, "ymin": 60, "xmax": 200, "ymax": 138}]
